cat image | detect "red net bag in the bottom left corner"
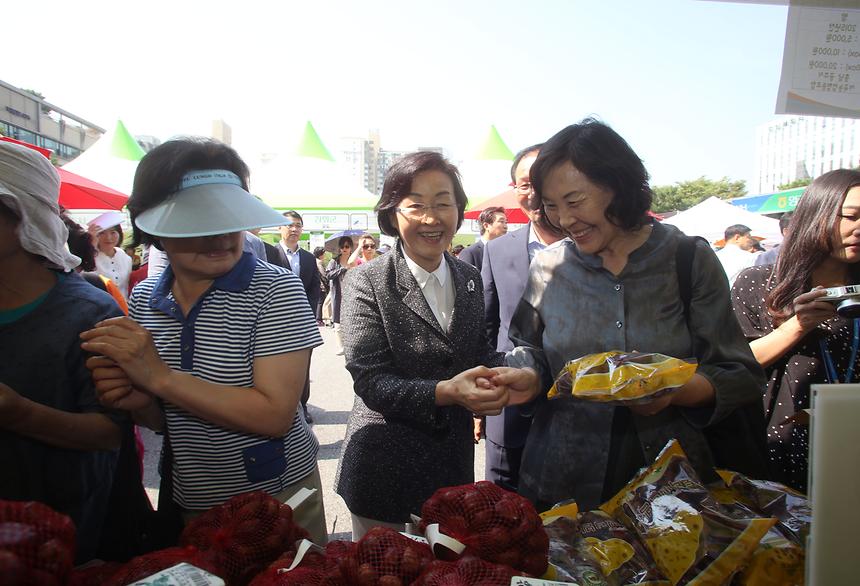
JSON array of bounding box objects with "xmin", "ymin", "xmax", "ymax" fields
[{"xmin": 0, "ymin": 501, "xmax": 75, "ymax": 586}]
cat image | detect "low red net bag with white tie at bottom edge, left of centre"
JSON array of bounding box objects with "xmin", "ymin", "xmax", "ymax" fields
[{"xmin": 249, "ymin": 541, "xmax": 358, "ymax": 586}]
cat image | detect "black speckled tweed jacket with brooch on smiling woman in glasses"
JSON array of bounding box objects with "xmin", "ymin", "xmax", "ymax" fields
[{"xmin": 335, "ymin": 243, "xmax": 504, "ymax": 523}]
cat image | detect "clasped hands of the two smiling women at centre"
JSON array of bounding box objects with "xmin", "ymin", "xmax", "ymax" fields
[{"xmin": 436, "ymin": 366, "xmax": 540, "ymax": 415}]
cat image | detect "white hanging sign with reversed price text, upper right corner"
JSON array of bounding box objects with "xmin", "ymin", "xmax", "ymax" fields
[{"xmin": 776, "ymin": 5, "xmax": 860, "ymax": 118}]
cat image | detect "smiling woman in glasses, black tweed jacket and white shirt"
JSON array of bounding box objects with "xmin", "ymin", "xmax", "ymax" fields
[{"xmin": 335, "ymin": 152, "xmax": 524, "ymax": 539}]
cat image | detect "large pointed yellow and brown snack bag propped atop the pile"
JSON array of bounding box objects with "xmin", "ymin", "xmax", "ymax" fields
[{"xmin": 600, "ymin": 440, "xmax": 776, "ymax": 585}]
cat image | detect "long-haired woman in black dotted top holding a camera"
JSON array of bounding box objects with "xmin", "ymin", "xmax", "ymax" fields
[{"xmin": 732, "ymin": 169, "xmax": 860, "ymax": 492}]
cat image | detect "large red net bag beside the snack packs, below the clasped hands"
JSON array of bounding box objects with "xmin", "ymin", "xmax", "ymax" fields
[{"xmin": 420, "ymin": 481, "xmax": 549, "ymax": 576}]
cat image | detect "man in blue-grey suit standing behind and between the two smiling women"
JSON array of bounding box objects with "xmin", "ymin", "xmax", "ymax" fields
[{"xmin": 481, "ymin": 145, "xmax": 561, "ymax": 491}]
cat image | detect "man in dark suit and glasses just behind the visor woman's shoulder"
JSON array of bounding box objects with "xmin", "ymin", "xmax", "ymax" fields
[{"xmin": 266, "ymin": 210, "xmax": 320, "ymax": 423}]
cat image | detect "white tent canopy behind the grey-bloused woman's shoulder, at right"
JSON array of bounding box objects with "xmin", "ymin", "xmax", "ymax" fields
[{"xmin": 663, "ymin": 197, "xmax": 782, "ymax": 243}]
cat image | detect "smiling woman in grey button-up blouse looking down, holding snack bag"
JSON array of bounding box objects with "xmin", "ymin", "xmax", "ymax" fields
[{"xmin": 499, "ymin": 119, "xmax": 766, "ymax": 510}]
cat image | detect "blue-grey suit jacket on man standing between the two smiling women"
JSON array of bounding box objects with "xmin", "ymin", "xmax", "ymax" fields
[{"xmin": 480, "ymin": 224, "xmax": 531, "ymax": 448}]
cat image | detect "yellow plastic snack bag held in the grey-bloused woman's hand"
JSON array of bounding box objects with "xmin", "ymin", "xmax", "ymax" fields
[{"xmin": 547, "ymin": 350, "xmax": 696, "ymax": 405}]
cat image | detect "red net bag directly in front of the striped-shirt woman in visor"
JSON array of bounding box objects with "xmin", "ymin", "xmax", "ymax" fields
[{"xmin": 179, "ymin": 491, "xmax": 309, "ymax": 586}]
